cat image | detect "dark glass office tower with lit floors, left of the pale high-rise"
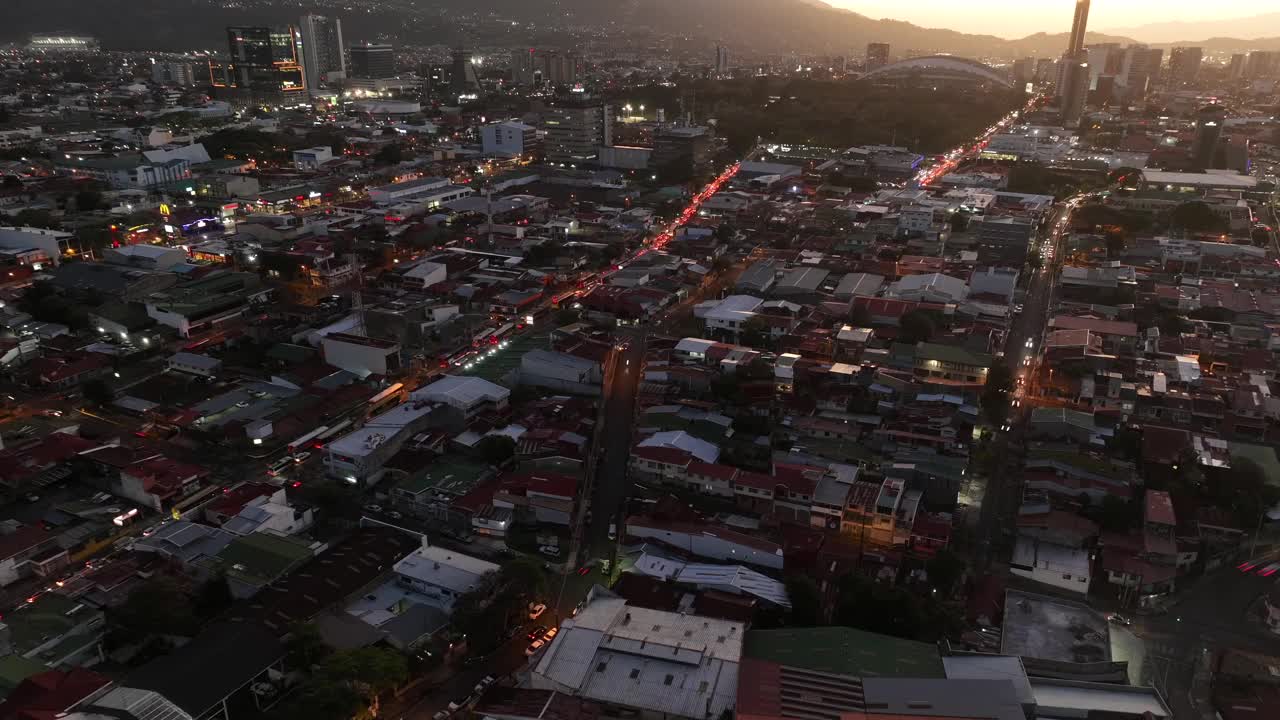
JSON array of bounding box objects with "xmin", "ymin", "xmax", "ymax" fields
[{"xmin": 215, "ymin": 26, "xmax": 307, "ymax": 96}]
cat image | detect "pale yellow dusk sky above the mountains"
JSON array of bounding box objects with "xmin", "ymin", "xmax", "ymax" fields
[{"xmin": 827, "ymin": 0, "xmax": 1259, "ymax": 37}]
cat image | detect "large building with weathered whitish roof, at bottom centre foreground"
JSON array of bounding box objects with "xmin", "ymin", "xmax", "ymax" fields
[{"xmin": 530, "ymin": 589, "xmax": 745, "ymax": 720}]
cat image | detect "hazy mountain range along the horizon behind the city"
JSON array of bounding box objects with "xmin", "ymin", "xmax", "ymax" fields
[{"xmin": 0, "ymin": 0, "xmax": 1280, "ymax": 58}]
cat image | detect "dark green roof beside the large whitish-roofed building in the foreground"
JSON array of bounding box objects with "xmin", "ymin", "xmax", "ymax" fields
[{"xmin": 742, "ymin": 626, "xmax": 946, "ymax": 678}]
